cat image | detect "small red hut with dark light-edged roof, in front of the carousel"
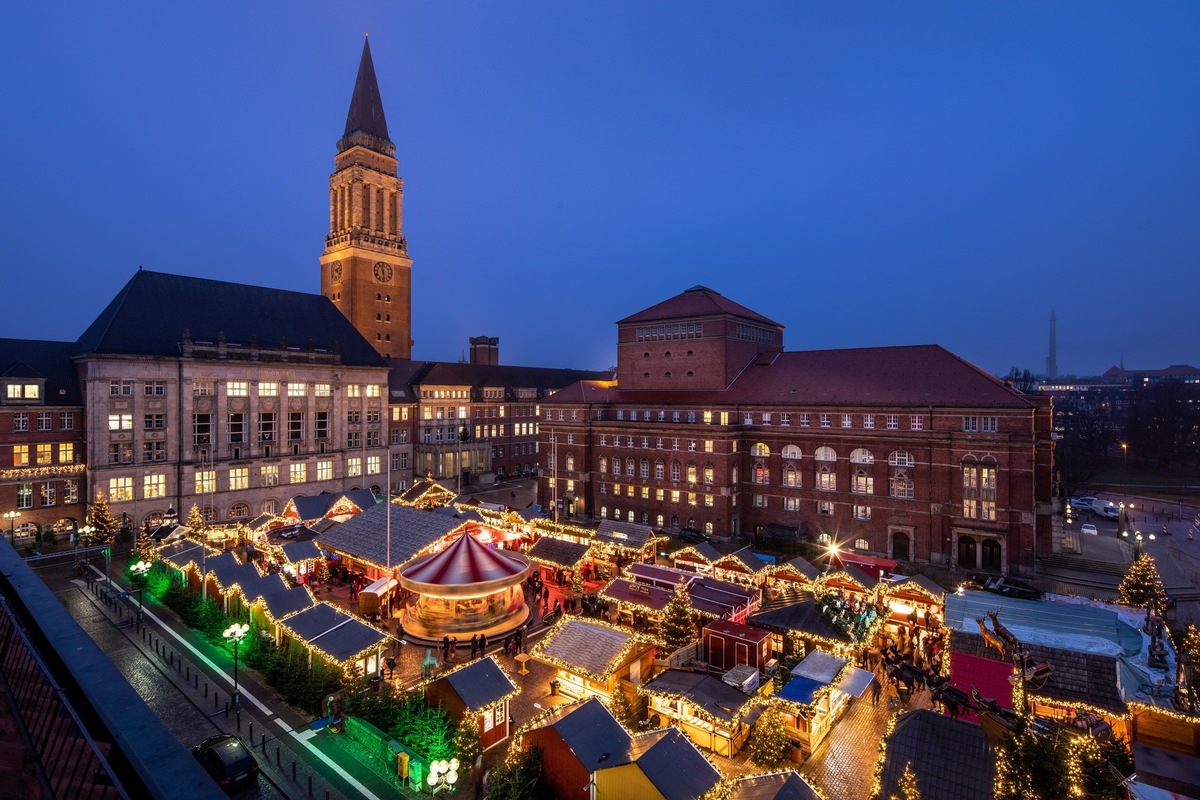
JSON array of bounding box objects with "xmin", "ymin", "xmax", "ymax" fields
[{"xmin": 424, "ymin": 656, "xmax": 520, "ymax": 750}]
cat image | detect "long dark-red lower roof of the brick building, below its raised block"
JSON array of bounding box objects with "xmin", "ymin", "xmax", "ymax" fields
[{"xmin": 551, "ymin": 344, "xmax": 1036, "ymax": 409}]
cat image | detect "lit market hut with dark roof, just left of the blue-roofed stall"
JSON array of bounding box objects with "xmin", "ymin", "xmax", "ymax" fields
[{"xmin": 642, "ymin": 669, "xmax": 757, "ymax": 758}]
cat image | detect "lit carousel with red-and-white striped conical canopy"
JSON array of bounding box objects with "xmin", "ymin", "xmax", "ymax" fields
[{"xmin": 400, "ymin": 533, "xmax": 529, "ymax": 639}]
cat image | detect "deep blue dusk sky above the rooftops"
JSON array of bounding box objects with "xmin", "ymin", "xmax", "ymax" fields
[{"xmin": 0, "ymin": 0, "xmax": 1200, "ymax": 374}]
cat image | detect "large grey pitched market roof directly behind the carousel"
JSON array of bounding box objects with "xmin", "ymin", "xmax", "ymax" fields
[{"xmin": 317, "ymin": 503, "xmax": 463, "ymax": 570}]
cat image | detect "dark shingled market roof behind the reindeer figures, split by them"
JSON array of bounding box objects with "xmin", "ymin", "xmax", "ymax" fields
[{"xmin": 950, "ymin": 633, "xmax": 1126, "ymax": 714}]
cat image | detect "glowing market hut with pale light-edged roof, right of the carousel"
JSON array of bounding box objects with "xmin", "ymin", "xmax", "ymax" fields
[{"xmin": 529, "ymin": 616, "xmax": 658, "ymax": 702}]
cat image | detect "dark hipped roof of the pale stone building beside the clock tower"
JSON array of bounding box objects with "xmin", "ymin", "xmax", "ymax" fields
[{"xmin": 77, "ymin": 270, "xmax": 386, "ymax": 367}]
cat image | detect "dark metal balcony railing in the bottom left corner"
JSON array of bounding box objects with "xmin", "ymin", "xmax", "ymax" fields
[{"xmin": 0, "ymin": 597, "xmax": 130, "ymax": 799}]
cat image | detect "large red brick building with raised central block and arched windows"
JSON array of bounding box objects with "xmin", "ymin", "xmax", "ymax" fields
[{"xmin": 539, "ymin": 287, "xmax": 1054, "ymax": 576}]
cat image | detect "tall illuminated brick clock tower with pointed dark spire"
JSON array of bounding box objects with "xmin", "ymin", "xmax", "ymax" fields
[{"xmin": 320, "ymin": 35, "xmax": 413, "ymax": 359}]
